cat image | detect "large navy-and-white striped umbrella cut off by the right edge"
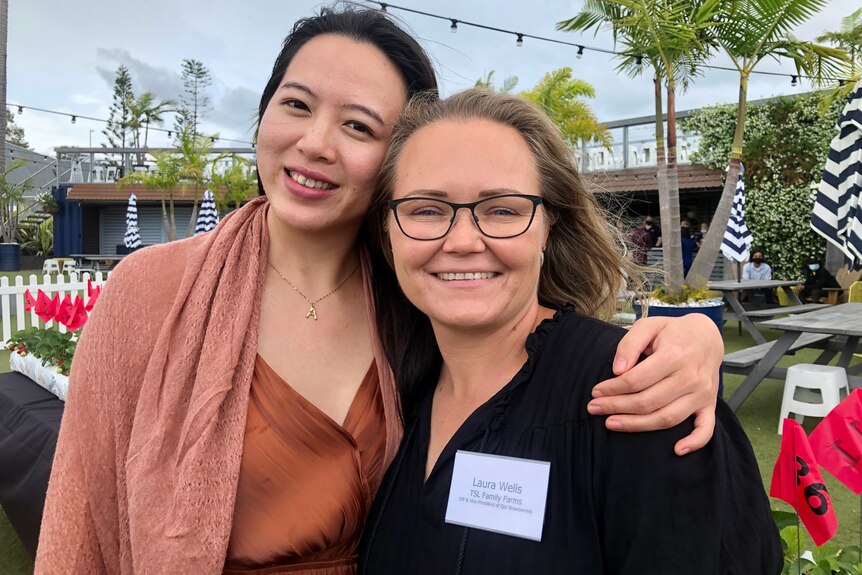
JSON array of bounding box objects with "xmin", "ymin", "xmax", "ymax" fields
[{"xmin": 811, "ymin": 80, "xmax": 862, "ymax": 269}]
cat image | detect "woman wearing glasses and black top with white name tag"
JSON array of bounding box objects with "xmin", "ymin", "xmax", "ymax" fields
[{"xmin": 360, "ymin": 90, "xmax": 783, "ymax": 575}]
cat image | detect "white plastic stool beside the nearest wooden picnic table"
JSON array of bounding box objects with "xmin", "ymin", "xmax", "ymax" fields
[{"xmin": 778, "ymin": 363, "xmax": 850, "ymax": 435}]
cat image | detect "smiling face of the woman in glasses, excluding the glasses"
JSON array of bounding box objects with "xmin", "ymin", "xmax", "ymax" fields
[{"xmin": 389, "ymin": 119, "xmax": 548, "ymax": 330}]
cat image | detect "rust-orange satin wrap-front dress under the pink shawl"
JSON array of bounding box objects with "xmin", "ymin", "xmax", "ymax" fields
[{"xmin": 225, "ymin": 355, "xmax": 386, "ymax": 575}]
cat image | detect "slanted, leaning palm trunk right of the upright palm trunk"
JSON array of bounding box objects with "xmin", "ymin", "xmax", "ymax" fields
[{"xmin": 686, "ymin": 74, "xmax": 748, "ymax": 286}]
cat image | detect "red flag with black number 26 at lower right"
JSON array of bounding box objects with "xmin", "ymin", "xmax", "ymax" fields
[{"xmin": 769, "ymin": 418, "xmax": 838, "ymax": 547}]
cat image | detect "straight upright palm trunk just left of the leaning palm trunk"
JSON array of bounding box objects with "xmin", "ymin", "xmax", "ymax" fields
[{"xmin": 653, "ymin": 78, "xmax": 683, "ymax": 292}]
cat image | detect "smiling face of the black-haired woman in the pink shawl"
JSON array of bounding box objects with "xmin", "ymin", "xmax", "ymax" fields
[{"xmin": 257, "ymin": 34, "xmax": 406, "ymax": 234}]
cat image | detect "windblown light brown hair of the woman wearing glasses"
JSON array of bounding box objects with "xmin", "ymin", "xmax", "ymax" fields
[{"xmin": 369, "ymin": 89, "xmax": 640, "ymax": 319}]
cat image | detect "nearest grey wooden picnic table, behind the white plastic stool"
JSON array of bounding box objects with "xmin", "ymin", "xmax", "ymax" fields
[{"xmin": 725, "ymin": 303, "xmax": 862, "ymax": 411}]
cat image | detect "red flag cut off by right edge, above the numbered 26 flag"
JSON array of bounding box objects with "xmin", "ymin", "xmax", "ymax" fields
[{"xmin": 811, "ymin": 389, "xmax": 862, "ymax": 495}]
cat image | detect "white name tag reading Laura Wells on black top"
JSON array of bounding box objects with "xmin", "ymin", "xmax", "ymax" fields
[{"xmin": 446, "ymin": 451, "xmax": 551, "ymax": 541}]
